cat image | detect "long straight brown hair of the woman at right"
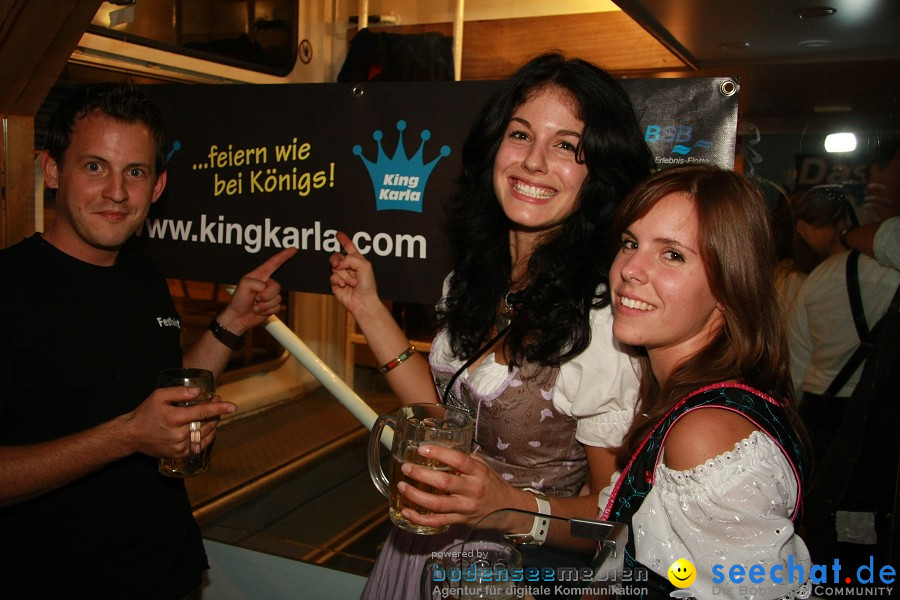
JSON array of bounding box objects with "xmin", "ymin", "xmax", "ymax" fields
[{"xmin": 613, "ymin": 166, "xmax": 805, "ymax": 468}]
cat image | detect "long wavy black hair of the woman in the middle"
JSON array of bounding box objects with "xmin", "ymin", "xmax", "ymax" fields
[{"xmin": 438, "ymin": 54, "xmax": 653, "ymax": 365}]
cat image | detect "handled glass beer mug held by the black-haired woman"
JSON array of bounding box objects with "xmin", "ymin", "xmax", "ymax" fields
[{"xmin": 369, "ymin": 404, "xmax": 475, "ymax": 535}]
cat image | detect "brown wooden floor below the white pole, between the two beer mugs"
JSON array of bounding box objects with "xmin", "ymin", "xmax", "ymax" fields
[{"xmin": 186, "ymin": 371, "xmax": 397, "ymax": 575}]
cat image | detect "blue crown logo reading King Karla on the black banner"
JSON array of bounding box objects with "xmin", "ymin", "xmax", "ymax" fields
[{"xmin": 353, "ymin": 119, "xmax": 450, "ymax": 213}]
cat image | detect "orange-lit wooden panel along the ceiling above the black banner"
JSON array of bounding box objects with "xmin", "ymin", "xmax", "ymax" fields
[{"xmin": 362, "ymin": 12, "xmax": 688, "ymax": 79}]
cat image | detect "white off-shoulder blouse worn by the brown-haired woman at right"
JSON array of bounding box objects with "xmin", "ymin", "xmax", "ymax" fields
[{"xmin": 600, "ymin": 431, "xmax": 811, "ymax": 600}]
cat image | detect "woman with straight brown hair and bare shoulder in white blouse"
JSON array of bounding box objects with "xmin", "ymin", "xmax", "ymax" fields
[{"xmin": 600, "ymin": 167, "xmax": 809, "ymax": 598}]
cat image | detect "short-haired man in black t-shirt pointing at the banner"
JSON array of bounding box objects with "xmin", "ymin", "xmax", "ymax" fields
[{"xmin": 0, "ymin": 84, "xmax": 295, "ymax": 599}]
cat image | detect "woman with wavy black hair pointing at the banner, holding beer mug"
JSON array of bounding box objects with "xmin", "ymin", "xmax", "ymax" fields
[{"xmin": 331, "ymin": 54, "xmax": 652, "ymax": 598}]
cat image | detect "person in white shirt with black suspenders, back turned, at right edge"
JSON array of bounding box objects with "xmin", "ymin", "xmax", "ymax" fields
[{"xmin": 788, "ymin": 137, "xmax": 900, "ymax": 565}]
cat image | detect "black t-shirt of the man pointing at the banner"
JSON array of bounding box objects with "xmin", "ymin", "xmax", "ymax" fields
[{"xmin": 0, "ymin": 234, "xmax": 207, "ymax": 599}]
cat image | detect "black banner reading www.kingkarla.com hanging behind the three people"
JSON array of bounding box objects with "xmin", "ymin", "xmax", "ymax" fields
[{"xmin": 139, "ymin": 78, "xmax": 737, "ymax": 304}]
